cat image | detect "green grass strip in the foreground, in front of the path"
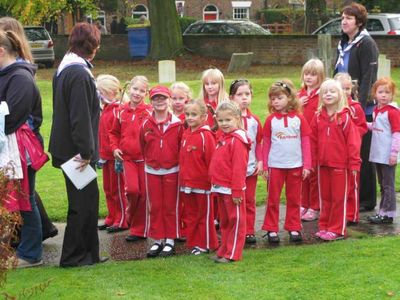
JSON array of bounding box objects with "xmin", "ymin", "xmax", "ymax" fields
[{"xmin": 4, "ymin": 236, "xmax": 400, "ymax": 299}]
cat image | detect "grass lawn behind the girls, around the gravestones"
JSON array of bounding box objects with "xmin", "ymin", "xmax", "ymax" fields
[{"xmin": 36, "ymin": 61, "xmax": 400, "ymax": 221}]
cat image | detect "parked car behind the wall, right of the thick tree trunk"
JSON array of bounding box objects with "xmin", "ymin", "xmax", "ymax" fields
[{"xmin": 183, "ymin": 20, "xmax": 271, "ymax": 35}]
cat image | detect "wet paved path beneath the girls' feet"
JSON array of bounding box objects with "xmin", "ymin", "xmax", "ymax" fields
[{"xmin": 43, "ymin": 198, "xmax": 400, "ymax": 265}]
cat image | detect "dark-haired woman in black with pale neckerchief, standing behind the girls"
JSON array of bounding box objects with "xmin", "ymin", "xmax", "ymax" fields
[{"xmin": 335, "ymin": 2, "xmax": 379, "ymax": 211}]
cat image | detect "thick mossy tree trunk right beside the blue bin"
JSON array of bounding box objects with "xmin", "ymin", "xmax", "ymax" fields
[{"xmin": 148, "ymin": 0, "xmax": 183, "ymax": 59}]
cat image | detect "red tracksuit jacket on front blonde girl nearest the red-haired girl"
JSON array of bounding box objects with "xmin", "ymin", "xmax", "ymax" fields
[{"xmin": 311, "ymin": 108, "xmax": 361, "ymax": 171}]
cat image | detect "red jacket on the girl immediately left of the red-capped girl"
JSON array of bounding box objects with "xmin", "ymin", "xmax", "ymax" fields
[{"xmin": 110, "ymin": 103, "xmax": 152, "ymax": 160}]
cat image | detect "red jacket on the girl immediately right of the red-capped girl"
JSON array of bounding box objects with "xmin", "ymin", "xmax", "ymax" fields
[{"xmin": 179, "ymin": 125, "xmax": 215, "ymax": 191}]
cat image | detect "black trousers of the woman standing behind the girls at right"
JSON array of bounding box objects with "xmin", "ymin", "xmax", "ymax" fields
[{"xmin": 360, "ymin": 115, "xmax": 376, "ymax": 210}]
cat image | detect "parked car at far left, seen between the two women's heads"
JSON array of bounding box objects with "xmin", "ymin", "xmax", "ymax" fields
[{"xmin": 24, "ymin": 26, "xmax": 54, "ymax": 68}]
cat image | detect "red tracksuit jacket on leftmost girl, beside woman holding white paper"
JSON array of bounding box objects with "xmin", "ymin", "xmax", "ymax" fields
[{"xmin": 99, "ymin": 101, "xmax": 120, "ymax": 160}]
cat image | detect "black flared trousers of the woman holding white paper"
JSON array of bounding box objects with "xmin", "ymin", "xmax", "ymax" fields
[{"xmin": 60, "ymin": 166, "xmax": 99, "ymax": 267}]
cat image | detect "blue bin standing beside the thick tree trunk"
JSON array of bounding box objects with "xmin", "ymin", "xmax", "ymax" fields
[{"xmin": 127, "ymin": 27, "xmax": 151, "ymax": 58}]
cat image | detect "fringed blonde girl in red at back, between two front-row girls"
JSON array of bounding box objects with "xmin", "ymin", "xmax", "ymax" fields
[{"xmin": 297, "ymin": 58, "xmax": 325, "ymax": 221}]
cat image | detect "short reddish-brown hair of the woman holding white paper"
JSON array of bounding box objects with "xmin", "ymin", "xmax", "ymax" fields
[{"xmin": 68, "ymin": 22, "xmax": 101, "ymax": 58}]
